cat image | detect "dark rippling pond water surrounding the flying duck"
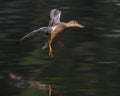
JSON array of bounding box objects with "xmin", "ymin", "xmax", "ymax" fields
[{"xmin": 0, "ymin": 0, "xmax": 120, "ymax": 96}]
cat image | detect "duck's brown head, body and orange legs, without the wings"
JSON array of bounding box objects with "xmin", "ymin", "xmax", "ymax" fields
[{"xmin": 48, "ymin": 20, "xmax": 84, "ymax": 57}]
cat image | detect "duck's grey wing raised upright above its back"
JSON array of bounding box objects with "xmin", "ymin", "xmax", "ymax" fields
[{"xmin": 49, "ymin": 9, "xmax": 61, "ymax": 26}]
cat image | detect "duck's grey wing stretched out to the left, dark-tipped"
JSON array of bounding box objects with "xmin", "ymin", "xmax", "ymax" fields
[{"xmin": 20, "ymin": 27, "xmax": 52, "ymax": 41}]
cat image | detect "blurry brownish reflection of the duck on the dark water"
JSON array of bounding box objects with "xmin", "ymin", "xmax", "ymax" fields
[{"xmin": 8, "ymin": 73, "xmax": 62, "ymax": 96}]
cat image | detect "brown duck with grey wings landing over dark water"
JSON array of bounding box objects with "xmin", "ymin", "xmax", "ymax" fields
[{"xmin": 19, "ymin": 9, "xmax": 84, "ymax": 57}]
